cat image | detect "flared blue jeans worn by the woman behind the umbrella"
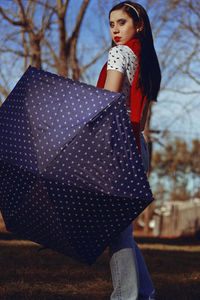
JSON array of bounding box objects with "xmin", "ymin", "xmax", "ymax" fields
[{"xmin": 109, "ymin": 134, "xmax": 154, "ymax": 300}]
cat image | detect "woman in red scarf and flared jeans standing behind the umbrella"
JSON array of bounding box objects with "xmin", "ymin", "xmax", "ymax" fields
[{"xmin": 97, "ymin": 1, "xmax": 161, "ymax": 300}]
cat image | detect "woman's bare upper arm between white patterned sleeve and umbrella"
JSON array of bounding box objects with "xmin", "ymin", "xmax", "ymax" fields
[{"xmin": 104, "ymin": 70, "xmax": 124, "ymax": 93}]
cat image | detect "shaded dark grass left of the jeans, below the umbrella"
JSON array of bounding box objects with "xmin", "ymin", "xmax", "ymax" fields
[{"xmin": 0, "ymin": 243, "xmax": 112, "ymax": 300}]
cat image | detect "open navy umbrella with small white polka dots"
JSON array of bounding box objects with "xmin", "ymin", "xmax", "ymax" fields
[{"xmin": 0, "ymin": 67, "xmax": 153, "ymax": 264}]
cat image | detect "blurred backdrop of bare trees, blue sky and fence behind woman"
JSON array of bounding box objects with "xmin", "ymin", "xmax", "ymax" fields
[{"xmin": 0, "ymin": 0, "xmax": 200, "ymax": 237}]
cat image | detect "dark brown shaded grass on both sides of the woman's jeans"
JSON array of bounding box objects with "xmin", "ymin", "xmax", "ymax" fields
[{"xmin": 0, "ymin": 236, "xmax": 200, "ymax": 300}]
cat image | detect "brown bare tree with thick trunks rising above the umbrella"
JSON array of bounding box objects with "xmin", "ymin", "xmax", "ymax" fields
[{"xmin": 0, "ymin": 0, "xmax": 90, "ymax": 79}]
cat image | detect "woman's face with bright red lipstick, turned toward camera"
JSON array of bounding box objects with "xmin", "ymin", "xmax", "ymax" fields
[{"xmin": 110, "ymin": 9, "xmax": 136, "ymax": 45}]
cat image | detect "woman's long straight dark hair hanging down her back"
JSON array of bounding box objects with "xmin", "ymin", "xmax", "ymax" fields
[{"xmin": 109, "ymin": 1, "xmax": 161, "ymax": 101}]
